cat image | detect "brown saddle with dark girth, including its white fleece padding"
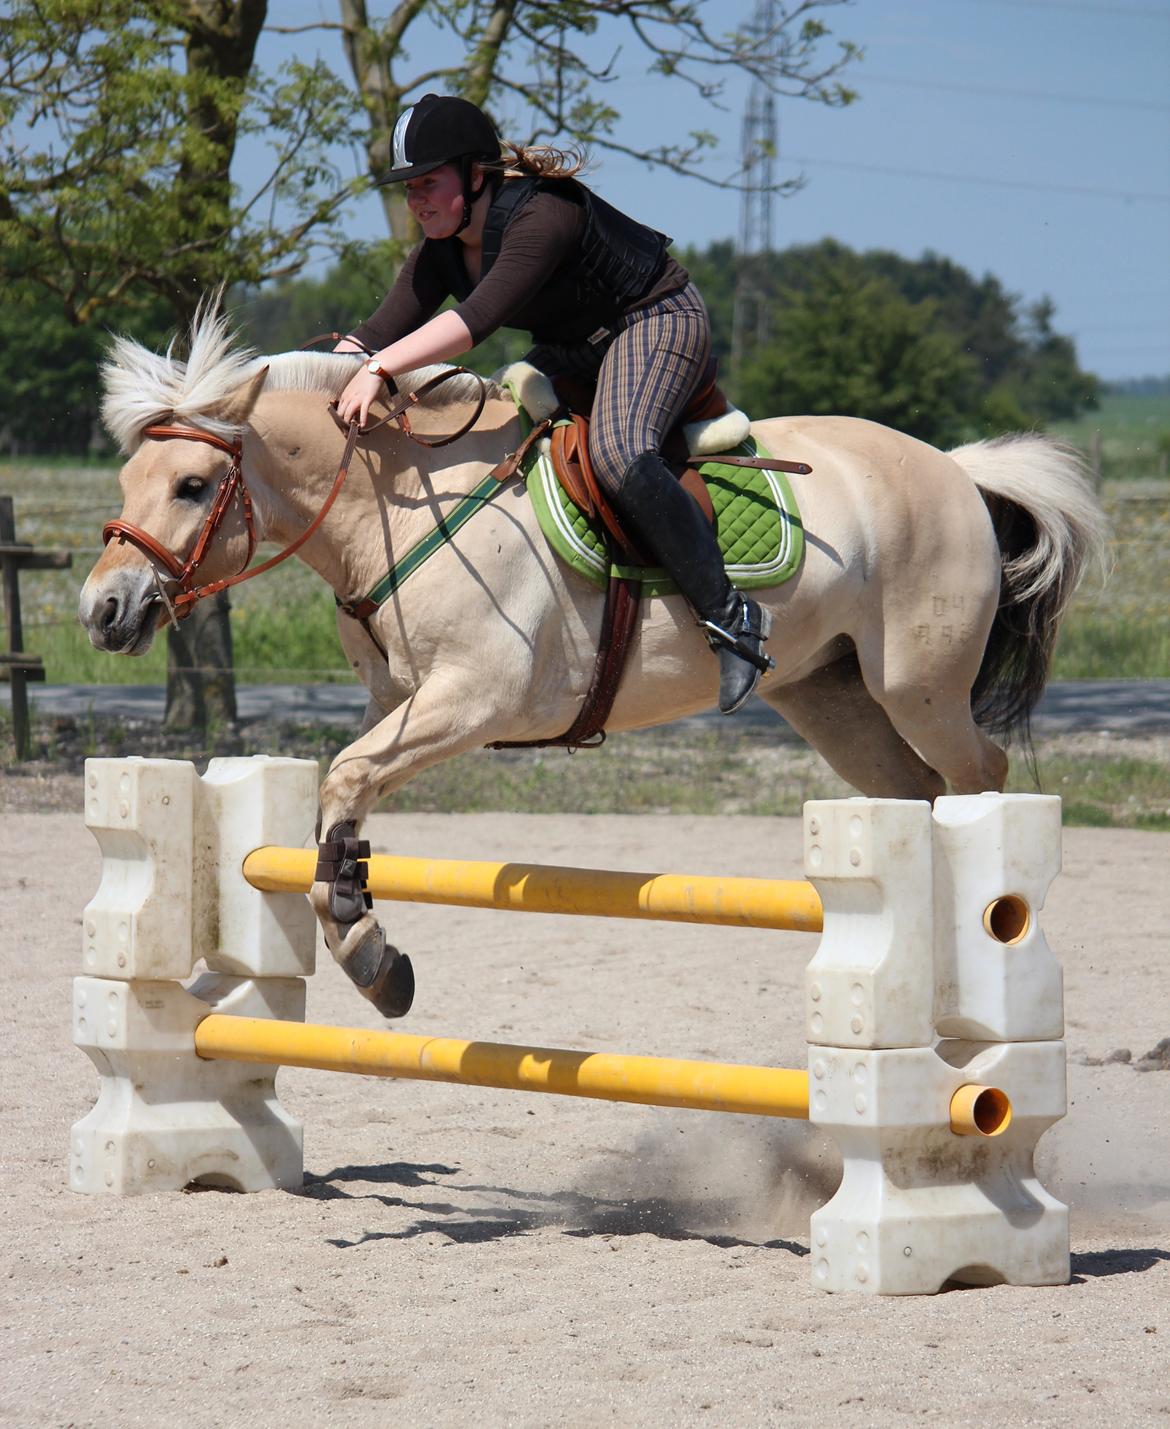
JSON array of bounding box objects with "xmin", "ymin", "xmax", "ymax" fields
[{"xmin": 489, "ymin": 359, "xmax": 811, "ymax": 750}]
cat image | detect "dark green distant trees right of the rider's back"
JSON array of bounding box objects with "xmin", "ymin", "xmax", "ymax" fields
[{"xmin": 680, "ymin": 239, "xmax": 1099, "ymax": 446}]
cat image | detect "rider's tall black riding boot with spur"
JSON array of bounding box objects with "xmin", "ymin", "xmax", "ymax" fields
[{"xmin": 613, "ymin": 452, "xmax": 774, "ymax": 715}]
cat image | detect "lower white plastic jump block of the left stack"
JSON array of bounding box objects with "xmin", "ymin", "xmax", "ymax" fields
[{"xmin": 69, "ymin": 975, "xmax": 304, "ymax": 1196}]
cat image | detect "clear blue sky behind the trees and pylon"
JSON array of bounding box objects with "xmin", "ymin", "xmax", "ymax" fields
[{"xmin": 244, "ymin": 0, "xmax": 1170, "ymax": 380}]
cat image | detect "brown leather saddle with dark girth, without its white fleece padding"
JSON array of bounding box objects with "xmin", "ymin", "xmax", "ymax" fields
[{"xmin": 489, "ymin": 359, "xmax": 811, "ymax": 750}]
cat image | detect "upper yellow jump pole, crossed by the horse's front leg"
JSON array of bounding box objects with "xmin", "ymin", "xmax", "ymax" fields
[{"xmin": 244, "ymin": 847, "xmax": 821, "ymax": 933}]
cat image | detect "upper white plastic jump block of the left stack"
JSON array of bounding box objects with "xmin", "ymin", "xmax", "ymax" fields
[{"xmin": 81, "ymin": 756, "xmax": 317, "ymax": 979}]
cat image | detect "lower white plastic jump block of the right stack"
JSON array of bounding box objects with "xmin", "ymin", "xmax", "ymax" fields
[{"xmin": 809, "ymin": 1042, "xmax": 1069, "ymax": 1295}]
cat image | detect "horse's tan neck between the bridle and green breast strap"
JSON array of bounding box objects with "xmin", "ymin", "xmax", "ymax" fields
[{"xmin": 254, "ymin": 392, "xmax": 519, "ymax": 594}]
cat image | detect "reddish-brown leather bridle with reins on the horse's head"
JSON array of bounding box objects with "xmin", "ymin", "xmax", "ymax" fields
[{"xmin": 101, "ymin": 362, "xmax": 487, "ymax": 622}]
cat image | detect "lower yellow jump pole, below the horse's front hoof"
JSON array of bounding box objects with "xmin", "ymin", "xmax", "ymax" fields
[{"xmin": 194, "ymin": 1013, "xmax": 809, "ymax": 1119}]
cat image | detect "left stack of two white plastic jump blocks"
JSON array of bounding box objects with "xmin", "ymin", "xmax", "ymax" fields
[{"xmin": 69, "ymin": 756, "xmax": 317, "ymax": 1196}]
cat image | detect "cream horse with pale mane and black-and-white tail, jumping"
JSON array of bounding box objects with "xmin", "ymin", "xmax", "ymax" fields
[{"xmin": 79, "ymin": 307, "xmax": 1106, "ymax": 1015}]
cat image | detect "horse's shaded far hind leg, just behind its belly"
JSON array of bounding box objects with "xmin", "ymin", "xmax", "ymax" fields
[{"xmin": 760, "ymin": 653, "xmax": 946, "ymax": 800}]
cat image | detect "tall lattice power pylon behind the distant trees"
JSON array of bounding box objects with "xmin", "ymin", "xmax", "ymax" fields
[{"xmin": 731, "ymin": 0, "xmax": 780, "ymax": 376}]
